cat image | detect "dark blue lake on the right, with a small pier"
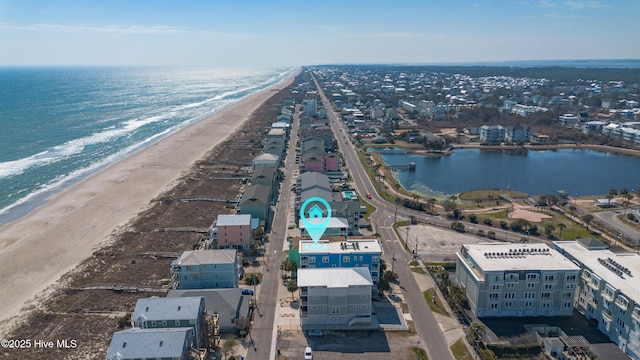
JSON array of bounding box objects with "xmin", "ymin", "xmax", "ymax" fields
[{"xmin": 382, "ymin": 149, "xmax": 640, "ymax": 198}]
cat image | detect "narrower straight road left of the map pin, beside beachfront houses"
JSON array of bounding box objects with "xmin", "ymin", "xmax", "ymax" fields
[{"xmin": 246, "ymin": 105, "xmax": 300, "ymax": 359}]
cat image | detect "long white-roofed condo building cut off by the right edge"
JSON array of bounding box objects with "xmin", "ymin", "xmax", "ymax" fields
[{"xmin": 554, "ymin": 239, "xmax": 640, "ymax": 360}]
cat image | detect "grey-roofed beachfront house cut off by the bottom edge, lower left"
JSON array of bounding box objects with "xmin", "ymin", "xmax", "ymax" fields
[{"xmin": 106, "ymin": 327, "xmax": 194, "ymax": 360}]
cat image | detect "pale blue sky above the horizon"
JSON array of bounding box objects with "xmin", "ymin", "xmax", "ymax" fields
[{"xmin": 0, "ymin": 0, "xmax": 640, "ymax": 66}]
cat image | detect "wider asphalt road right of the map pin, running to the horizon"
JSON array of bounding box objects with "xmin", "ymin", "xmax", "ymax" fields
[{"xmin": 314, "ymin": 77, "xmax": 453, "ymax": 359}]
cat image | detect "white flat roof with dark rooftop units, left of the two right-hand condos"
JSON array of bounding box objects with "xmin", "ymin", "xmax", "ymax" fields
[{"xmin": 461, "ymin": 243, "xmax": 580, "ymax": 278}]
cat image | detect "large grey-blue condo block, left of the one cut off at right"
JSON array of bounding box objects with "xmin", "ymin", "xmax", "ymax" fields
[{"xmin": 456, "ymin": 244, "xmax": 580, "ymax": 317}]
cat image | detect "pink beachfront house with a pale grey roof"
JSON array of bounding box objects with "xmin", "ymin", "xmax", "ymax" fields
[{"xmin": 211, "ymin": 214, "xmax": 253, "ymax": 249}]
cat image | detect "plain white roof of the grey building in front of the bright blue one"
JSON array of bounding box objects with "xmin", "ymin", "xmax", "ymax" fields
[{"xmin": 298, "ymin": 267, "xmax": 373, "ymax": 288}]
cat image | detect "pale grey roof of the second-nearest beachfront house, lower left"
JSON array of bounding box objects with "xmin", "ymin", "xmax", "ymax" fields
[{"xmin": 132, "ymin": 296, "xmax": 204, "ymax": 324}]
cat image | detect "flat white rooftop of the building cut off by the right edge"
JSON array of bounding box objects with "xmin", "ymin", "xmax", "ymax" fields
[{"xmin": 553, "ymin": 241, "xmax": 640, "ymax": 304}]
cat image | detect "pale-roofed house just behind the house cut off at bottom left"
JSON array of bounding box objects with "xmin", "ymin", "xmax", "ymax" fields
[{"xmin": 131, "ymin": 296, "xmax": 206, "ymax": 347}]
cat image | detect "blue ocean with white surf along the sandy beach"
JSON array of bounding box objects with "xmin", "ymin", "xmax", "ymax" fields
[{"xmin": 0, "ymin": 67, "xmax": 295, "ymax": 225}]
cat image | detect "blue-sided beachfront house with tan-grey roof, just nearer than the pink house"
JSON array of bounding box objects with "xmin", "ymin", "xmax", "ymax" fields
[{"xmin": 171, "ymin": 249, "xmax": 242, "ymax": 290}]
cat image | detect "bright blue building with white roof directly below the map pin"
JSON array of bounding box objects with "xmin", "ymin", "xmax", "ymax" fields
[{"xmin": 289, "ymin": 239, "xmax": 382, "ymax": 285}]
